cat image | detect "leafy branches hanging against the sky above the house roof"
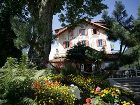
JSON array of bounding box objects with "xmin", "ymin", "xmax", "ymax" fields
[{"xmin": 59, "ymin": 0, "xmax": 107, "ymax": 25}]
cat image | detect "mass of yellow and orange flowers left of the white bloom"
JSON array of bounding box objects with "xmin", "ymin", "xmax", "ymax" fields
[{"xmin": 33, "ymin": 80, "xmax": 76, "ymax": 105}]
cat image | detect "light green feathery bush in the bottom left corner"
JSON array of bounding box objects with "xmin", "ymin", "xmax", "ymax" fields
[{"xmin": 0, "ymin": 56, "xmax": 34, "ymax": 105}]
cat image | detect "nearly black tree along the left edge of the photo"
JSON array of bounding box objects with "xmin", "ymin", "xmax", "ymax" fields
[{"xmin": 0, "ymin": 0, "xmax": 25, "ymax": 67}]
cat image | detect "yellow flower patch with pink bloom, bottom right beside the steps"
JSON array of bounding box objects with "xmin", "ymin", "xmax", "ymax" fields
[{"xmin": 84, "ymin": 86, "xmax": 135, "ymax": 105}]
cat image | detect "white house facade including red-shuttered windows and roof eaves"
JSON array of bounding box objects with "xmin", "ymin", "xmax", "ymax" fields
[{"xmin": 55, "ymin": 21, "xmax": 111, "ymax": 57}]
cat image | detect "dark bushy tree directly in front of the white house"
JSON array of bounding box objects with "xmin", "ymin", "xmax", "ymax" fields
[{"xmin": 66, "ymin": 43, "xmax": 104, "ymax": 71}]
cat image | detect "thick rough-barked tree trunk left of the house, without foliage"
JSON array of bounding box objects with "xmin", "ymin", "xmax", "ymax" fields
[{"xmin": 29, "ymin": 0, "xmax": 56, "ymax": 69}]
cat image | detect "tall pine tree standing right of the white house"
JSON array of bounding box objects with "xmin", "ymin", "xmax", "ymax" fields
[{"xmin": 102, "ymin": 1, "xmax": 137, "ymax": 65}]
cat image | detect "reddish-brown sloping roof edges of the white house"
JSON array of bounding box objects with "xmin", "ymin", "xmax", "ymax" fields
[{"xmin": 55, "ymin": 20, "xmax": 109, "ymax": 36}]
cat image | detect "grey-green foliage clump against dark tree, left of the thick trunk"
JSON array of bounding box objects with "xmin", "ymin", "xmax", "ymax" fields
[{"xmin": 11, "ymin": 16, "xmax": 32, "ymax": 49}]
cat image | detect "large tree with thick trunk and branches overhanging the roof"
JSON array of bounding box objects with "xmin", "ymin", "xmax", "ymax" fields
[{"xmin": 27, "ymin": 0, "xmax": 107, "ymax": 68}]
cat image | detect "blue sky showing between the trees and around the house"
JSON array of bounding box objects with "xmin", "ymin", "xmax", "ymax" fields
[{"xmin": 50, "ymin": 0, "xmax": 140, "ymax": 59}]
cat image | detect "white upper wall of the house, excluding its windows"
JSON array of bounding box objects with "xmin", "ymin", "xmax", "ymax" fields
[{"xmin": 57, "ymin": 24, "xmax": 111, "ymax": 56}]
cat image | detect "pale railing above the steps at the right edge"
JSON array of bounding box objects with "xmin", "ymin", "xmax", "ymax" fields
[{"xmin": 110, "ymin": 69, "xmax": 140, "ymax": 78}]
